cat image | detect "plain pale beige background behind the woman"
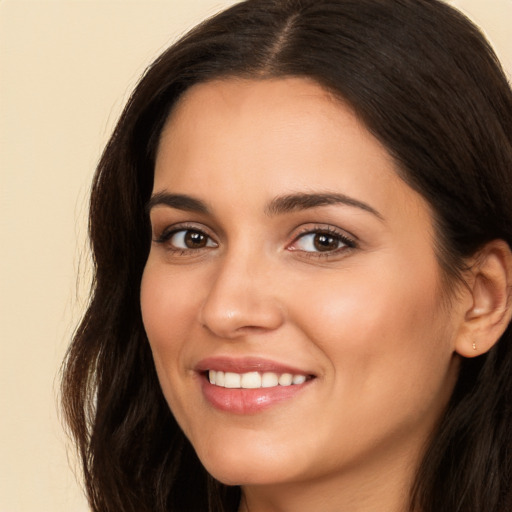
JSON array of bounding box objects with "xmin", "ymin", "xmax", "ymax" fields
[{"xmin": 0, "ymin": 0, "xmax": 512, "ymax": 512}]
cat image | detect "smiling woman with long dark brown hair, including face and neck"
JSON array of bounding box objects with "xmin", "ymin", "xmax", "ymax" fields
[{"xmin": 63, "ymin": 0, "xmax": 512, "ymax": 512}]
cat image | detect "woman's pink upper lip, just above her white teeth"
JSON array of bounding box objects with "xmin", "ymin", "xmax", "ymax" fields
[{"xmin": 195, "ymin": 356, "xmax": 313, "ymax": 375}]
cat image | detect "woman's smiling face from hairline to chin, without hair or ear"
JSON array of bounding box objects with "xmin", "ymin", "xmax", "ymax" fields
[{"xmin": 141, "ymin": 78, "xmax": 460, "ymax": 485}]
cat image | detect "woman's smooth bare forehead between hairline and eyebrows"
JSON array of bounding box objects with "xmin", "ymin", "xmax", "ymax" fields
[{"xmin": 154, "ymin": 78, "xmax": 426, "ymax": 225}]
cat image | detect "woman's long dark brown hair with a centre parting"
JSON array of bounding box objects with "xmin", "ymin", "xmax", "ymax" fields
[{"xmin": 62, "ymin": 0, "xmax": 512, "ymax": 512}]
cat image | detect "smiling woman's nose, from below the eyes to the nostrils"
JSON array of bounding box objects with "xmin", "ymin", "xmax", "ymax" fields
[{"xmin": 200, "ymin": 250, "xmax": 284, "ymax": 339}]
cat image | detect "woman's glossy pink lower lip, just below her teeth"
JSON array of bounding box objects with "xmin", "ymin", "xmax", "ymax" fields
[{"xmin": 202, "ymin": 376, "xmax": 312, "ymax": 414}]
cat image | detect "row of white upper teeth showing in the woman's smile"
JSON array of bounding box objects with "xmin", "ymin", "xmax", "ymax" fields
[{"xmin": 208, "ymin": 370, "xmax": 307, "ymax": 389}]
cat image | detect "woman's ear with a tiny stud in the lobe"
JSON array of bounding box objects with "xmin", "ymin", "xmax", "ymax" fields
[{"xmin": 455, "ymin": 240, "xmax": 512, "ymax": 357}]
